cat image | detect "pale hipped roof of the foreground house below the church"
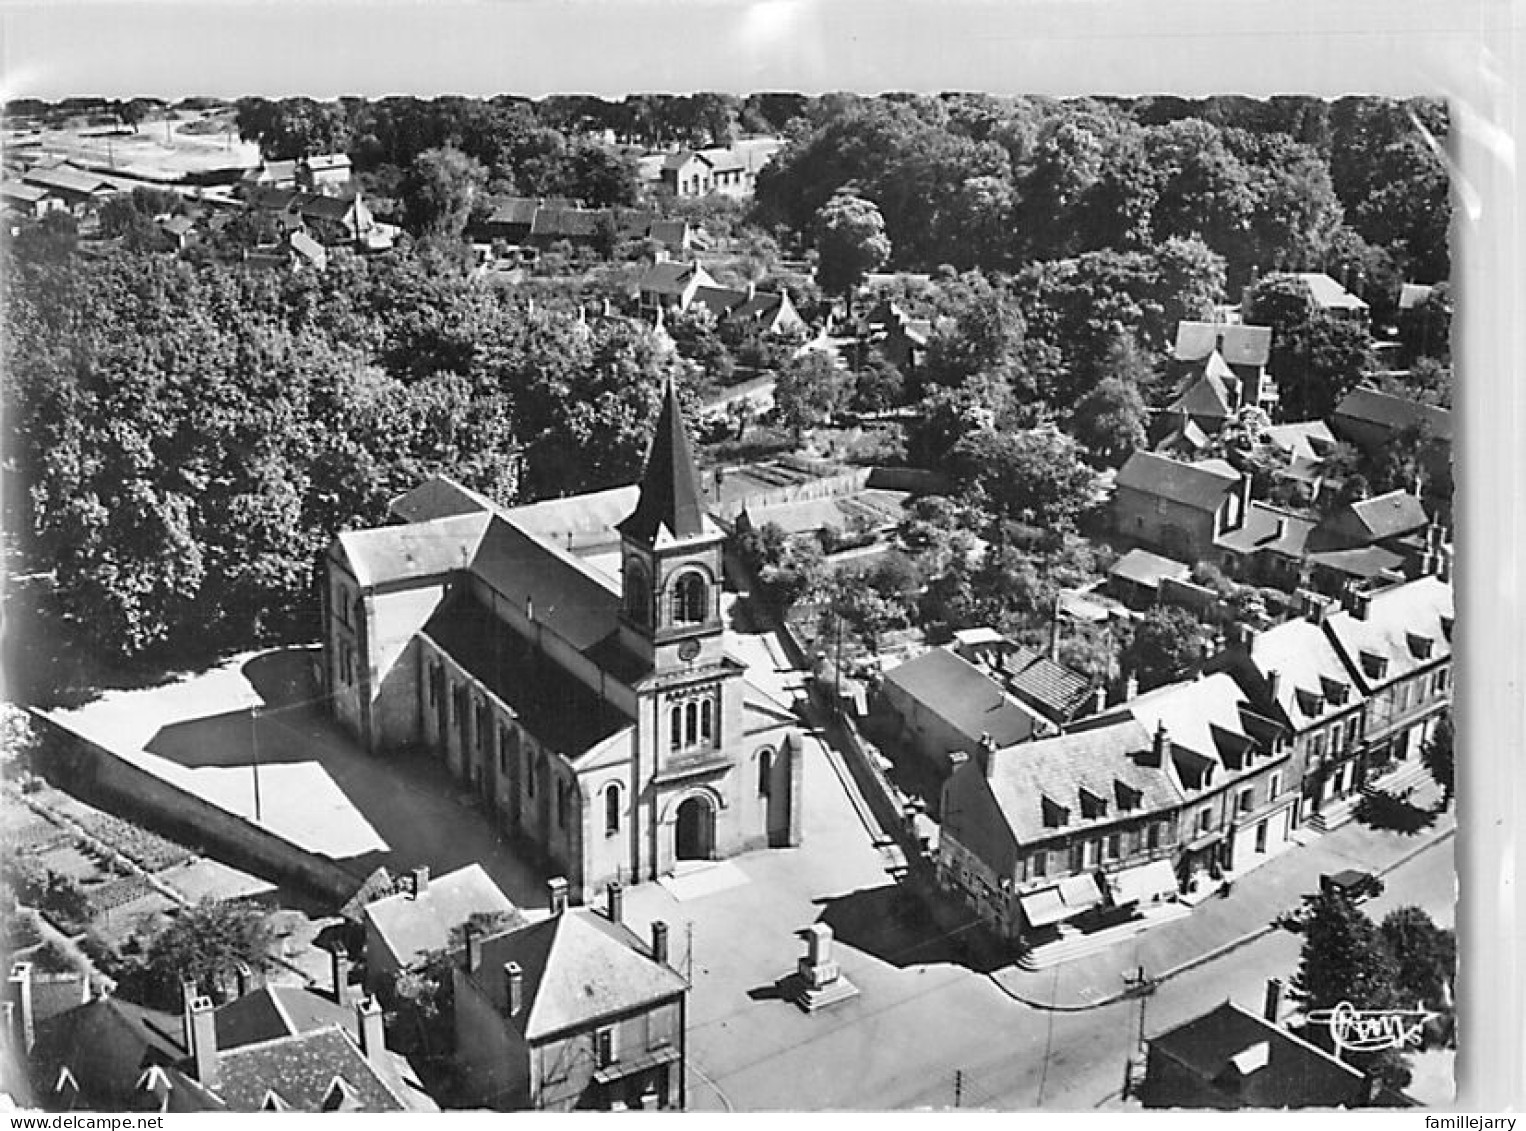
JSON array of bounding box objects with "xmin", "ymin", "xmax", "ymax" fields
[{"xmin": 467, "ymin": 911, "xmax": 688, "ymax": 1041}]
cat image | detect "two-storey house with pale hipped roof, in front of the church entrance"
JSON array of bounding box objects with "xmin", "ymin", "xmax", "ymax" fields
[{"xmin": 453, "ymin": 881, "xmax": 688, "ymax": 1111}]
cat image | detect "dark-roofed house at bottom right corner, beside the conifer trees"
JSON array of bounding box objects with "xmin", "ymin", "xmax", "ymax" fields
[{"xmin": 1137, "ymin": 1001, "xmax": 1396, "ymax": 1111}]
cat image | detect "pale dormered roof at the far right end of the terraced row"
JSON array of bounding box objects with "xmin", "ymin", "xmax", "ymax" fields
[{"xmin": 1325, "ymin": 577, "xmax": 1456, "ymax": 691}]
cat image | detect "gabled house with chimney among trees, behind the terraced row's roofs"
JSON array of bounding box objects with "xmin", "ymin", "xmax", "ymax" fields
[{"xmin": 1111, "ymin": 452, "xmax": 1250, "ymax": 562}]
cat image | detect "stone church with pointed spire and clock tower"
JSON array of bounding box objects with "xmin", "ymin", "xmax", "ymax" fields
[{"xmin": 324, "ymin": 383, "xmax": 801, "ymax": 899}]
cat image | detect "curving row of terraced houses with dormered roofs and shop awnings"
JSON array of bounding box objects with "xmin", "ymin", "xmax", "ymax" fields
[{"xmin": 938, "ymin": 574, "xmax": 1454, "ymax": 942}]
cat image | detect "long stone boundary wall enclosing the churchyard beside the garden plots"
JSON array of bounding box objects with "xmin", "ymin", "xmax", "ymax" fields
[{"xmin": 27, "ymin": 708, "xmax": 363, "ymax": 905}]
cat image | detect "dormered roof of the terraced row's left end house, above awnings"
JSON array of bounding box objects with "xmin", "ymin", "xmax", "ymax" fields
[{"xmin": 960, "ymin": 719, "xmax": 1181, "ymax": 844}]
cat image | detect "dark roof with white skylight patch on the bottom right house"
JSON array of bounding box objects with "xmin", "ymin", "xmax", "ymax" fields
[{"xmin": 1146, "ymin": 1001, "xmax": 1364, "ymax": 1108}]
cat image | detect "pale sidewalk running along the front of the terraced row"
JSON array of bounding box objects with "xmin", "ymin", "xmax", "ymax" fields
[{"xmin": 990, "ymin": 780, "xmax": 1457, "ymax": 1012}]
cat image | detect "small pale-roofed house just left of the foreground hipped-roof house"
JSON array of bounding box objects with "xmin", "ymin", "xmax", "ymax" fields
[{"xmin": 362, "ymin": 864, "xmax": 525, "ymax": 992}]
